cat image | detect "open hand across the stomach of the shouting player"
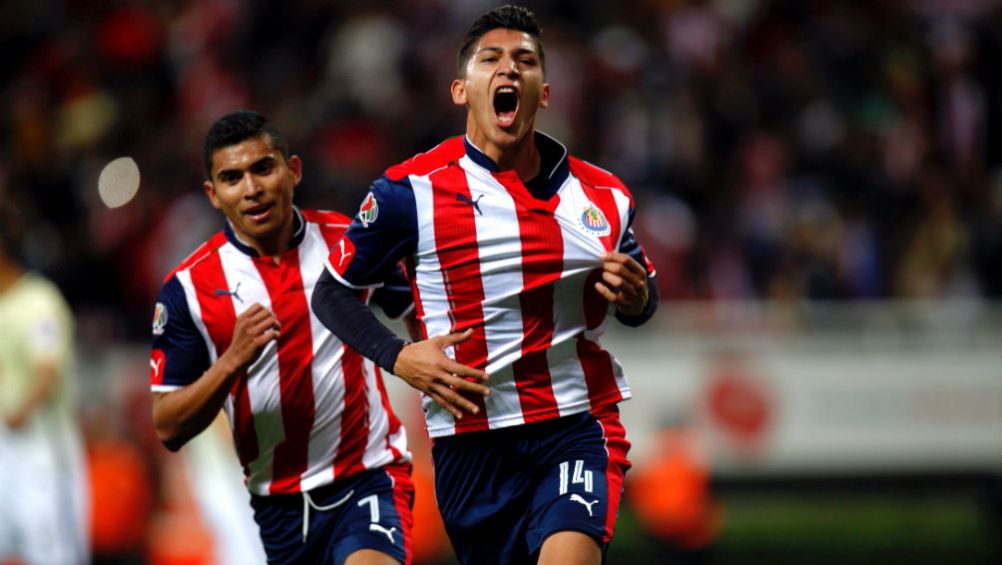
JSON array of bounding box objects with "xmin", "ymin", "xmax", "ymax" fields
[{"xmin": 393, "ymin": 330, "xmax": 491, "ymax": 420}]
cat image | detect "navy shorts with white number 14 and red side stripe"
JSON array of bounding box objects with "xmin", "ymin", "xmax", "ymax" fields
[{"xmin": 432, "ymin": 405, "xmax": 630, "ymax": 565}]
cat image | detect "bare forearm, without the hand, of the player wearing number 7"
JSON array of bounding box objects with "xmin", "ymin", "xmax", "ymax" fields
[{"xmin": 153, "ymin": 354, "xmax": 242, "ymax": 451}]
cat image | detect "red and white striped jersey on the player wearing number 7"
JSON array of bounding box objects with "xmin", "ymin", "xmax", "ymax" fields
[{"xmin": 150, "ymin": 210, "xmax": 410, "ymax": 495}]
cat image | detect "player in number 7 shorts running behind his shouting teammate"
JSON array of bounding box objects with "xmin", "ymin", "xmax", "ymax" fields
[{"xmin": 150, "ymin": 111, "xmax": 414, "ymax": 565}]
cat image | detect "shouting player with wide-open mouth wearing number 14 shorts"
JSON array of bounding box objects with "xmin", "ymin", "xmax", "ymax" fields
[{"xmin": 313, "ymin": 6, "xmax": 657, "ymax": 565}]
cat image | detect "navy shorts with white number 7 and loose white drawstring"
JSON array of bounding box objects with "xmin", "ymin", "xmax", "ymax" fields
[{"xmin": 251, "ymin": 464, "xmax": 414, "ymax": 565}]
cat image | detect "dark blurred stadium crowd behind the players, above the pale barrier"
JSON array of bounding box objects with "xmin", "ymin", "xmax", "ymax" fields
[{"xmin": 0, "ymin": 0, "xmax": 1002, "ymax": 340}]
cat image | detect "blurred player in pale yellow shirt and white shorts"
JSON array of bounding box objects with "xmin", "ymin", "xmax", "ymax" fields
[{"xmin": 0, "ymin": 203, "xmax": 90, "ymax": 565}]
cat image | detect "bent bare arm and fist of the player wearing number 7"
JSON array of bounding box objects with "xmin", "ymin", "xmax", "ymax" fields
[{"xmin": 153, "ymin": 304, "xmax": 280, "ymax": 451}]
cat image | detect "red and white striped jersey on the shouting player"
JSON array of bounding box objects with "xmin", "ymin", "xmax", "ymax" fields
[{"xmin": 328, "ymin": 132, "xmax": 654, "ymax": 437}]
